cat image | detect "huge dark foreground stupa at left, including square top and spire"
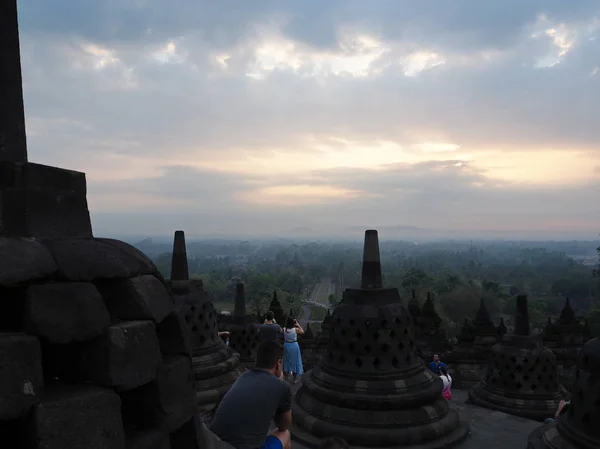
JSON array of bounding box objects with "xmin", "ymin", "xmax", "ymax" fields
[{"xmin": 0, "ymin": 0, "xmax": 198, "ymax": 449}]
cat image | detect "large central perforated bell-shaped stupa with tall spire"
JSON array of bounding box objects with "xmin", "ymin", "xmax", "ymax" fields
[{"xmin": 291, "ymin": 230, "xmax": 468, "ymax": 449}]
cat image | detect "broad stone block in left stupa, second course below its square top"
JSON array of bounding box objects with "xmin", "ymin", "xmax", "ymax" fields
[{"xmin": 25, "ymin": 282, "xmax": 110, "ymax": 343}]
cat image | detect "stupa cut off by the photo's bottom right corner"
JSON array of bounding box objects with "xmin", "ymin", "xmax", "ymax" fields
[{"xmin": 527, "ymin": 338, "xmax": 600, "ymax": 449}]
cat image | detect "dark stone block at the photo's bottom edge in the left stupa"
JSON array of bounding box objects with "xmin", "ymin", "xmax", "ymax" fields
[{"xmin": 30, "ymin": 385, "xmax": 125, "ymax": 449}]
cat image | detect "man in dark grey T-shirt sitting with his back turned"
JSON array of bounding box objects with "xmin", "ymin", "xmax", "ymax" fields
[{"xmin": 210, "ymin": 341, "xmax": 292, "ymax": 449}]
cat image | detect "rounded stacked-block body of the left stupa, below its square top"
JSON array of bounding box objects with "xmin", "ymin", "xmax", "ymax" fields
[{"xmin": 0, "ymin": 238, "xmax": 202, "ymax": 449}]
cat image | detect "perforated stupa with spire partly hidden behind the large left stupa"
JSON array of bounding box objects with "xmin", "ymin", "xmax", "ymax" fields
[{"xmin": 171, "ymin": 231, "xmax": 241, "ymax": 410}]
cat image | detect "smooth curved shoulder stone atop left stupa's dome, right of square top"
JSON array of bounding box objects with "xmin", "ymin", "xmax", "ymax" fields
[{"xmin": 44, "ymin": 238, "xmax": 156, "ymax": 282}]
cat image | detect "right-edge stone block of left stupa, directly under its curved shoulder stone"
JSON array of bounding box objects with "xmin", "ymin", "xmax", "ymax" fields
[{"xmin": 97, "ymin": 274, "xmax": 174, "ymax": 323}]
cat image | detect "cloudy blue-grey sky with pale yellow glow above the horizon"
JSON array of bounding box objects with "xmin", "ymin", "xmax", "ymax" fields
[{"xmin": 19, "ymin": 0, "xmax": 600, "ymax": 238}]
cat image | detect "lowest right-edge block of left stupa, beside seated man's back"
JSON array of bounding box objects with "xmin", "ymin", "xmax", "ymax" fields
[{"xmin": 121, "ymin": 356, "xmax": 196, "ymax": 432}]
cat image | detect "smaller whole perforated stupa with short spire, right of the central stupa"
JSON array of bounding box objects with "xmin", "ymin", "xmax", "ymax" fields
[{"xmin": 469, "ymin": 295, "xmax": 566, "ymax": 420}]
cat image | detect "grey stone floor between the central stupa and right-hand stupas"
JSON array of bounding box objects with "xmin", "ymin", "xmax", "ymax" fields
[{"xmin": 292, "ymin": 384, "xmax": 541, "ymax": 449}]
